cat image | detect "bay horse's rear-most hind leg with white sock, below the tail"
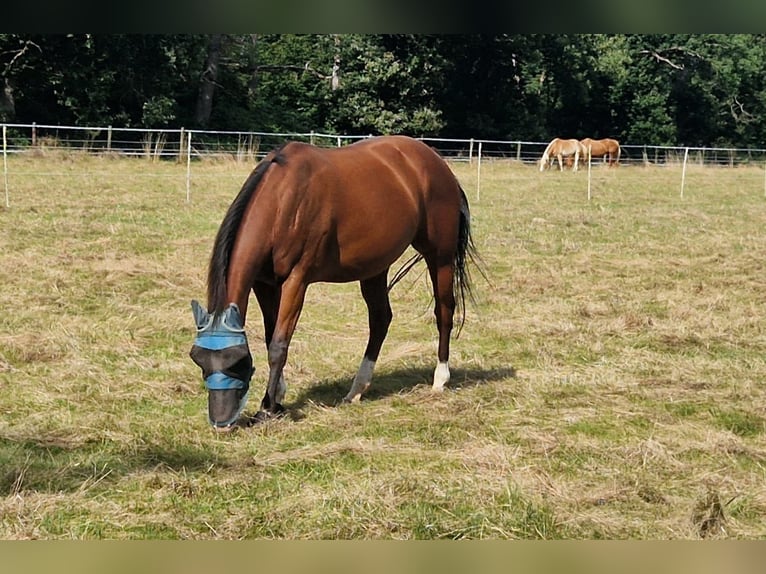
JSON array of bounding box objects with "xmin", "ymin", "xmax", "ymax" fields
[{"xmin": 426, "ymin": 257, "xmax": 455, "ymax": 392}]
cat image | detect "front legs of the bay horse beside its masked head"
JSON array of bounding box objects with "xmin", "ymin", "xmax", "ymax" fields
[{"xmin": 255, "ymin": 276, "xmax": 307, "ymax": 422}]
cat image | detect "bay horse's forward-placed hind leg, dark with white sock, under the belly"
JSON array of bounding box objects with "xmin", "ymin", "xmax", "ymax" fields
[{"xmin": 343, "ymin": 270, "xmax": 393, "ymax": 403}]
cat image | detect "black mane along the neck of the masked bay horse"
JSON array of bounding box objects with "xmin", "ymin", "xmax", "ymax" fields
[{"xmin": 207, "ymin": 144, "xmax": 286, "ymax": 316}]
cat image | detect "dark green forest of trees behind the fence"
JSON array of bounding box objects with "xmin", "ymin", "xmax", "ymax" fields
[{"xmin": 0, "ymin": 34, "xmax": 766, "ymax": 147}]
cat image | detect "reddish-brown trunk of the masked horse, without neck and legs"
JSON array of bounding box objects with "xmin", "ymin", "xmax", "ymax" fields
[{"xmin": 252, "ymin": 136, "xmax": 462, "ymax": 282}]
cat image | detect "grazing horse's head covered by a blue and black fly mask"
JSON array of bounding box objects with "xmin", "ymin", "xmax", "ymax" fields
[{"xmin": 189, "ymin": 301, "xmax": 254, "ymax": 430}]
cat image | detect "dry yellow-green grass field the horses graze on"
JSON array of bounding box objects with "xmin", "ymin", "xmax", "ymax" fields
[{"xmin": 0, "ymin": 156, "xmax": 766, "ymax": 539}]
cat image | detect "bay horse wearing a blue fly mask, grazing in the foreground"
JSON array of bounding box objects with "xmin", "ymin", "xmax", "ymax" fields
[{"xmin": 190, "ymin": 136, "xmax": 475, "ymax": 430}]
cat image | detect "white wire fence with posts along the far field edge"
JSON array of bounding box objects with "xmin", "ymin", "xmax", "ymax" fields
[{"xmin": 0, "ymin": 123, "xmax": 766, "ymax": 206}]
